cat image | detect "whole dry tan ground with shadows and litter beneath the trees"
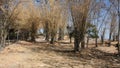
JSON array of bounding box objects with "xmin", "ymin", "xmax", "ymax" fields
[{"xmin": 0, "ymin": 37, "xmax": 120, "ymax": 68}]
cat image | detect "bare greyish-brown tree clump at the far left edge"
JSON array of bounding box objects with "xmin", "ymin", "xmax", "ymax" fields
[{"xmin": 0, "ymin": 0, "xmax": 21, "ymax": 47}]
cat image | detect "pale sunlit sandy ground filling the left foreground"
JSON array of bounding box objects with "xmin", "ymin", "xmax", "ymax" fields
[{"xmin": 0, "ymin": 42, "xmax": 92, "ymax": 68}]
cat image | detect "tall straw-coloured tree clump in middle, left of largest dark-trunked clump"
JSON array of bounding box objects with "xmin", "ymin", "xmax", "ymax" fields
[{"xmin": 43, "ymin": 0, "xmax": 67, "ymax": 44}]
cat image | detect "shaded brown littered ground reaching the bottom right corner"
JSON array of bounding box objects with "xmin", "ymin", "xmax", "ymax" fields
[{"xmin": 19, "ymin": 42, "xmax": 120, "ymax": 68}]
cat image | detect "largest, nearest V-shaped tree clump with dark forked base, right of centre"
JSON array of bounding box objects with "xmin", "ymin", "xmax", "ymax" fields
[{"xmin": 69, "ymin": 0, "xmax": 90, "ymax": 52}]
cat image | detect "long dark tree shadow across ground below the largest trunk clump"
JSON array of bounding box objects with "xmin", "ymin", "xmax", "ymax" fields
[{"xmin": 23, "ymin": 42, "xmax": 120, "ymax": 67}]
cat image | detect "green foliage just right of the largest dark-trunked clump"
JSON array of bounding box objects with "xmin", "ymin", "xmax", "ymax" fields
[{"xmin": 87, "ymin": 23, "xmax": 99, "ymax": 38}]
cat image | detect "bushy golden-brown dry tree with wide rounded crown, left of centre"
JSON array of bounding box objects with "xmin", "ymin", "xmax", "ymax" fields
[{"xmin": 16, "ymin": 0, "xmax": 41, "ymax": 42}]
